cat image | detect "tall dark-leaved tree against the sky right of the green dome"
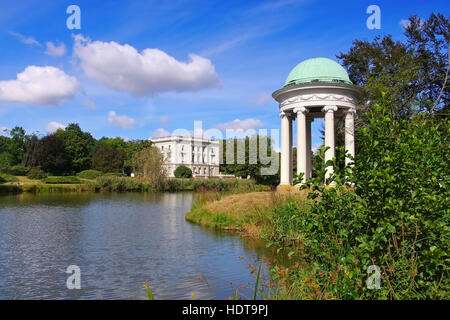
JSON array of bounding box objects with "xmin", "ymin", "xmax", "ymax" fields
[{"xmin": 337, "ymin": 14, "xmax": 450, "ymax": 118}]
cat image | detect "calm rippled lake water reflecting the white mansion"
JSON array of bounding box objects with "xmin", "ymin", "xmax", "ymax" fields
[{"xmin": 0, "ymin": 193, "xmax": 280, "ymax": 299}]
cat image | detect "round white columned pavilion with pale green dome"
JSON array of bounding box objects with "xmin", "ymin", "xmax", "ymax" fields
[{"xmin": 272, "ymin": 58, "xmax": 361, "ymax": 186}]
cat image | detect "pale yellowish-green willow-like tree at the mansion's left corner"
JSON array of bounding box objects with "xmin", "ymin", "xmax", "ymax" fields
[{"xmin": 132, "ymin": 146, "xmax": 165, "ymax": 188}]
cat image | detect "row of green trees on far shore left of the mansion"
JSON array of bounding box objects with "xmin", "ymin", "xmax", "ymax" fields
[{"xmin": 0, "ymin": 123, "xmax": 152, "ymax": 176}]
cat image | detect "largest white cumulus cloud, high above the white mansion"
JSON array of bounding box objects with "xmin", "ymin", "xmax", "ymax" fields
[{"xmin": 74, "ymin": 35, "xmax": 220, "ymax": 96}]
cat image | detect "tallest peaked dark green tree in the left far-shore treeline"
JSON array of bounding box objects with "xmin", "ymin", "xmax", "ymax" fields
[{"xmin": 55, "ymin": 123, "xmax": 95, "ymax": 172}]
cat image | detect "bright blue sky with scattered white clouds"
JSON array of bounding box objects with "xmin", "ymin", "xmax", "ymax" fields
[{"xmin": 0, "ymin": 0, "xmax": 450, "ymax": 148}]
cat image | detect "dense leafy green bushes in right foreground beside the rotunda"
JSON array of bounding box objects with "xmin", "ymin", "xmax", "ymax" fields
[{"xmin": 274, "ymin": 105, "xmax": 450, "ymax": 299}]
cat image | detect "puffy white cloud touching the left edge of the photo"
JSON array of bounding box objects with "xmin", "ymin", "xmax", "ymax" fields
[{"xmin": 0, "ymin": 66, "xmax": 80, "ymax": 105}]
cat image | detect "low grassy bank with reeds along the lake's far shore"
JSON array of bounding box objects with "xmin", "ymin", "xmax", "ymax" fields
[{"xmin": 0, "ymin": 176, "xmax": 270, "ymax": 194}]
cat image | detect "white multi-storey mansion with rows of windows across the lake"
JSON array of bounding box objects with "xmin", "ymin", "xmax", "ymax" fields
[{"xmin": 150, "ymin": 136, "xmax": 220, "ymax": 177}]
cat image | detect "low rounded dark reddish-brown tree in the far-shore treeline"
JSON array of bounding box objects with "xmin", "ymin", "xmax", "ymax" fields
[{"xmin": 92, "ymin": 145, "xmax": 126, "ymax": 172}]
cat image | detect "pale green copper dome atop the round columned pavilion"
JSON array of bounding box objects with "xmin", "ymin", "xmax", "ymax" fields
[{"xmin": 284, "ymin": 58, "xmax": 352, "ymax": 87}]
